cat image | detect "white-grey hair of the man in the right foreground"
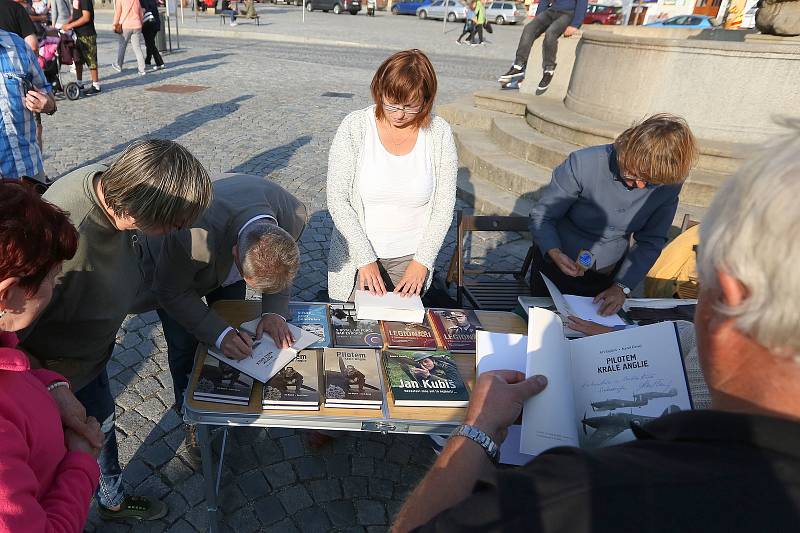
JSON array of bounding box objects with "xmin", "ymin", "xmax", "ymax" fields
[{"xmin": 697, "ymin": 129, "xmax": 800, "ymax": 361}]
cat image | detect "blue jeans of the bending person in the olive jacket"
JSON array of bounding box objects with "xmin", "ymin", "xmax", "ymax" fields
[{"xmin": 75, "ymin": 366, "xmax": 125, "ymax": 507}]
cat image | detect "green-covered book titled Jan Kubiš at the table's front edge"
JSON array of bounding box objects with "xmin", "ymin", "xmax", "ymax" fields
[{"xmin": 383, "ymin": 350, "xmax": 469, "ymax": 407}]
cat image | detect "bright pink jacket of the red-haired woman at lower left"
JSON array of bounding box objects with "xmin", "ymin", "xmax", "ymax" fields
[{"xmin": 0, "ymin": 332, "xmax": 100, "ymax": 533}]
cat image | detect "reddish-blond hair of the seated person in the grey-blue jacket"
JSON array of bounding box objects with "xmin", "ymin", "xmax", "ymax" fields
[{"xmin": 614, "ymin": 113, "xmax": 697, "ymax": 185}]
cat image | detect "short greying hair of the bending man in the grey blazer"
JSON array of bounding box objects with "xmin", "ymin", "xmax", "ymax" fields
[{"xmin": 237, "ymin": 220, "xmax": 300, "ymax": 294}]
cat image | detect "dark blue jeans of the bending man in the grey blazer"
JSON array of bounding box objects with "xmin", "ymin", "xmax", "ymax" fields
[{"xmin": 156, "ymin": 281, "xmax": 247, "ymax": 412}]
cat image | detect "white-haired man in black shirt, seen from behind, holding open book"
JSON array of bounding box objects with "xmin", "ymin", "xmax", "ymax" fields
[{"xmin": 393, "ymin": 133, "xmax": 800, "ymax": 533}]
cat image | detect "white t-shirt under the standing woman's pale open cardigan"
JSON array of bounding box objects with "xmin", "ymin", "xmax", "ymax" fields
[{"xmin": 358, "ymin": 113, "xmax": 434, "ymax": 259}]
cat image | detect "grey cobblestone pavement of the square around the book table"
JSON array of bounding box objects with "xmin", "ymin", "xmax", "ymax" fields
[{"xmin": 43, "ymin": 30, "xmax": 526, "ymax": 533}]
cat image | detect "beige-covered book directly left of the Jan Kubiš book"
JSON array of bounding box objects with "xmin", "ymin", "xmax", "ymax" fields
[{"xmin": 323, "ymin": 348, "xmax": 383, "ymax": 409}]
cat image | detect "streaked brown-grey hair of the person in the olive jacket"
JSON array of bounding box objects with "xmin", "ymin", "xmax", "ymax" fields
[{"xmin": 100, "ymin": 139, "xmax": 212, "ymax": 230}]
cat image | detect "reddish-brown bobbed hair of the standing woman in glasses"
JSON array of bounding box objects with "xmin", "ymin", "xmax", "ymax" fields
[{"xmin": 370, "ymin": 48, "xmax": 437, "ymax": 128}]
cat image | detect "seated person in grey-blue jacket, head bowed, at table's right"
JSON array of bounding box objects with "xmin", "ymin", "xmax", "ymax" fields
[{"xmin": 530, "ymin": 113, "xmax": 697, "ymax": 316}]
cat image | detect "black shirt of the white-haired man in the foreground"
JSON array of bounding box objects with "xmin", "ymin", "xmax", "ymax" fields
[{"xmin": 417, "ymin": 411, "xmax": 800, "ymax": 533}]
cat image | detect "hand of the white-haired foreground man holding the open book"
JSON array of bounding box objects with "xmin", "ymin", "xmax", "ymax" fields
[{"xmin": 464, "ymin": 370, "xmax": 547, "ymax": 445}]
